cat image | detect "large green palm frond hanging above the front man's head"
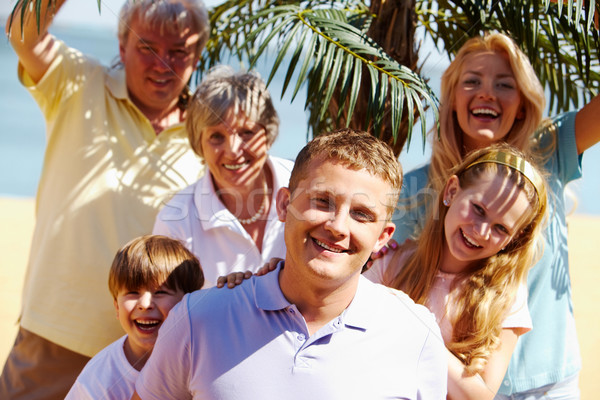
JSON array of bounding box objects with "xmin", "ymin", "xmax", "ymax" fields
[{"xmin": 202, "ymin": 1, "xmax": 437, "ymax": 148}]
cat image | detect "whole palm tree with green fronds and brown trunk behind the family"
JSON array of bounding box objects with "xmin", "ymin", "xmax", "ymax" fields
[{"xmin": 9, "ymin": 0, "xmax": 600, "ymax": 153}]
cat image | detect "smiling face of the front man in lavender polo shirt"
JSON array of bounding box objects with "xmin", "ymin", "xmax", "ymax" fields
[{"xmin": 277, "ymin": 160, "xmax": 394, "ymax": 288}]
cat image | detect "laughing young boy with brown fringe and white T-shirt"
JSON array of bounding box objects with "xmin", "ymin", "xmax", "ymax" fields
[{"xmin": 66, "ymin": 235, "xmax": 204, "ymax": 399}]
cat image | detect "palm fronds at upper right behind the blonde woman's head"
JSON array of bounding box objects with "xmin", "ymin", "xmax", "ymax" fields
[{"xmin": 417, "ymin": 0, "xmax": 600, "ymax": 113}]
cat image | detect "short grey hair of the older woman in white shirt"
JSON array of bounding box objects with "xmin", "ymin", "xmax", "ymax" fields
[{"xmin": 186, "ymin": 65, "xmax": 279, "ymax": 157}]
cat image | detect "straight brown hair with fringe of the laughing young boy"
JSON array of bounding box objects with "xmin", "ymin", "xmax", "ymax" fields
[{"xmin": 108, "ymin": 235, "xmax": 204, "ymax": 299}]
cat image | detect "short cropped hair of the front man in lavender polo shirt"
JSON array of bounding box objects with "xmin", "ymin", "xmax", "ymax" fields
[{"xmin": 289, "ymin": 128, "xmax": 402, "ymax": 218}]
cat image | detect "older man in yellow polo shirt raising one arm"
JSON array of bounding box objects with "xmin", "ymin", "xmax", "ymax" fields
[{"xmin": 0, "ymin": 0, "xmax": 209, "ymax": 400}]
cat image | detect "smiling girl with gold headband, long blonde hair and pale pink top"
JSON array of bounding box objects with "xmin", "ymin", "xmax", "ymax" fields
[{"xmin": 364, "ymin": 145, "xmax": 547, "ymax": 400}]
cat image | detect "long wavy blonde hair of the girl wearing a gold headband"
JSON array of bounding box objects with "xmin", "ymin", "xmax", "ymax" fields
[{"xmin": 391, "ymin": 144, "xmax": 547, "ymax": 374}]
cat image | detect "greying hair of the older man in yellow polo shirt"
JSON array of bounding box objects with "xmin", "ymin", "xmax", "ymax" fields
[{"xmin": 118, "ymin": 0, "xmax": 210, "ymax": 54}]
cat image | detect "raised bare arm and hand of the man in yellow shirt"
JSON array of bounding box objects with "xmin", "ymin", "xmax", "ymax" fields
[{"xmin": 6, "ymin": 0, "xmax": 65, "ymax": 83}]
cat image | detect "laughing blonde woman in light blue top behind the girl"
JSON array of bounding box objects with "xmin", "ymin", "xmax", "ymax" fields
[{"xmin": 393, "ymin": 33, "xmax": 600, "ymax": 399}]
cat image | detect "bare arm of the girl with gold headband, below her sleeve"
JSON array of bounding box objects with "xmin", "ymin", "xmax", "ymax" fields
[{"xmin": 446, "ymin": 328, "xmax": 519, "ymax": 400}]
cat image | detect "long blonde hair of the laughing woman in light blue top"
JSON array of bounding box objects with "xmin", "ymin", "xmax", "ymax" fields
[{"xmin": 429, "ymin": 33, "xmax": 546, "ymax": 191}]
